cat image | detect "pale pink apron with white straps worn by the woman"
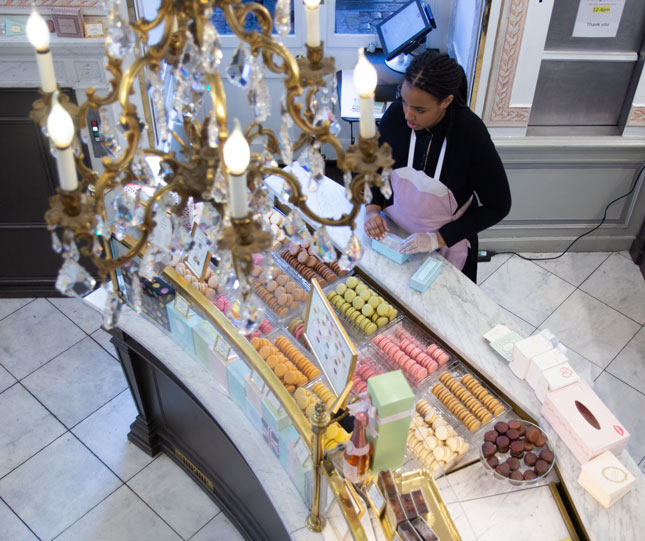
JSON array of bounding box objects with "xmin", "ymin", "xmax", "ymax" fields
[{"xmin": 385, "ymin": 130, "xmax": 473, "ymax": 270}]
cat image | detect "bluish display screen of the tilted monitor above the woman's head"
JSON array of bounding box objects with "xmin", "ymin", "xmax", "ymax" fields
[{"xmin": 376, "ymin": 0, "xmax": 432, "ymax": 60}]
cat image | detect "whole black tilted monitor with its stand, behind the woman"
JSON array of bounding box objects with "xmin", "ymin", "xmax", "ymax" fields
[{"xmin": 376, "ymin": 0, "xmax": 437, "ymax": 73}]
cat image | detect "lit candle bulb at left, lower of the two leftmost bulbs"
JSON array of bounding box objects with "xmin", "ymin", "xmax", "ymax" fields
[{"xmin": 47, "ymin": 90, "xmax": 78, "ymax": 192}]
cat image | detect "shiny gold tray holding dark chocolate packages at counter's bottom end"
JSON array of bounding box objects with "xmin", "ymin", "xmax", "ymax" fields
[{"xmin": 381, "ymin": 470, "xmax": 461, "ymax": 541}]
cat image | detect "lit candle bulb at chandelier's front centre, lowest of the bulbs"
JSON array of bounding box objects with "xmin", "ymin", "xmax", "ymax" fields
[{"xmin": 223, "ymin": 118, "xmax": 251, "ymax": 218}]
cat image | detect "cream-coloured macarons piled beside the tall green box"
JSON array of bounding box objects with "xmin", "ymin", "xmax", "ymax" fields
[{"xmin": 408, "ymin": 398, "xmax": 470, "ymax": 472}]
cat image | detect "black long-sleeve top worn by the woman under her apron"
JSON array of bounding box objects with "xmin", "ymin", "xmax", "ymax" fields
[{"xmin": 372, "ymin": 101, "xmax": 511, "ymax": 246}]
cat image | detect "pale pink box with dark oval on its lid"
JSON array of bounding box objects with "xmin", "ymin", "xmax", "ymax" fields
[{"xmin": 541, "ymin": 380, "xmax": 629, "ymax": 464}]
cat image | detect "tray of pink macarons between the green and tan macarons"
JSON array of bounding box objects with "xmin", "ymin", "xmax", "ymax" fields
[{"xmin": 370, "ymin": 319, "xmax": 454, "ymax": 390}]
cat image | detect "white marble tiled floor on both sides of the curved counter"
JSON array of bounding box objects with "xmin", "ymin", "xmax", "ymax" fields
[{"xmin": 0, "ymin": 252, "xmax": 645, "ymax": 541}]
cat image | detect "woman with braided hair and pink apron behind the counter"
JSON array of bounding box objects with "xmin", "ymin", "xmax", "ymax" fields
[{"xmin": 365, "ymin": 51, "xmax": 511, "ymax": 283}]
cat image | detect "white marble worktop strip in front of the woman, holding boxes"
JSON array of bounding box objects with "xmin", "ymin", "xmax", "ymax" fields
[{"xmin": 286, "ymin": 169, "xmax": 645, "ymax": 540}]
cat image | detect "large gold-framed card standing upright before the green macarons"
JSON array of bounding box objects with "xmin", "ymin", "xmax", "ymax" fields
[{"xmin": 304, "ymin": 279, "xmax": 358, "ymax": 395}]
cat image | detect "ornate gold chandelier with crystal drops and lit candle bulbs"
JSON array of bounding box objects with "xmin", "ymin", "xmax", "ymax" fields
[{"xmin": 27, "ymin": 0, "xmax": 393, "ymax": 330}]
